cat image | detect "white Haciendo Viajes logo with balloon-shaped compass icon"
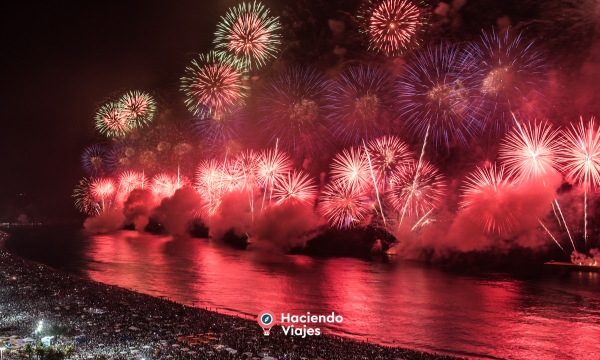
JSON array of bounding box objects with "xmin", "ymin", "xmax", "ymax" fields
[{"xmin": 257, "ymin": 310, "xmax": 344, "ymax": 338}]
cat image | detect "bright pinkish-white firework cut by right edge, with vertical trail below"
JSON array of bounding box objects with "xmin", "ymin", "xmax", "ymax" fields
[{"xmin": 561, "ymin": 118, "xmax": 600, "ymax": 244}]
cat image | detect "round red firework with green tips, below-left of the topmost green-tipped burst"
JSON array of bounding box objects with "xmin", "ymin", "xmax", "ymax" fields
[{"xmin": 181, "ymin": 52, "xmax": 245, "ymax": 118}]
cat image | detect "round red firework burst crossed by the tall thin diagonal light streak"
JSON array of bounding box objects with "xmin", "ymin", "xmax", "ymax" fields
[{"xmin": 386, "ymin": 161, "xmax": 446, "ymax": 217}]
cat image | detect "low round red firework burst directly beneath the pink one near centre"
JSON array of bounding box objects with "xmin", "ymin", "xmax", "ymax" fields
[{"xmin": 319, "ymin": 181, "xmax": 373, "ymax": 228}]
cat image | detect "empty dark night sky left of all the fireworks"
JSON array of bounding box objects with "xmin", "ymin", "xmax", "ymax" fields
[{"xmin": 0, "ymin": 0, "xmax": 264, "ymax": 218}]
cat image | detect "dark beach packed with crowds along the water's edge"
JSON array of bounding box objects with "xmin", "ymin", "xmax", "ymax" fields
[{"xmin": 0, "ymin": 231, "xmax": 458, "ymax": 359}]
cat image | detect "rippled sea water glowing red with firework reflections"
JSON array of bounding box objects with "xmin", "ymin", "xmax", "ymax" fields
[{"xmin": 87, "ymin": 231, "xmax": 600, "ymax": 359}]
